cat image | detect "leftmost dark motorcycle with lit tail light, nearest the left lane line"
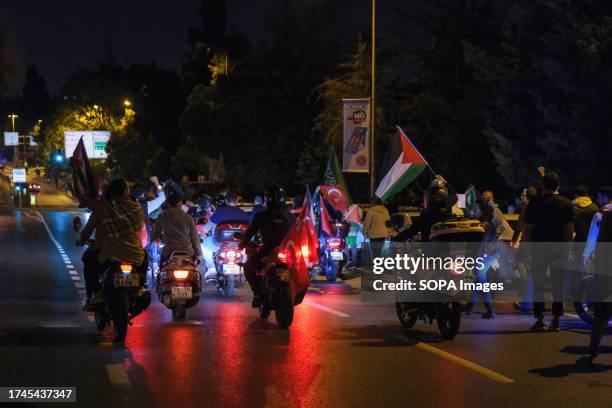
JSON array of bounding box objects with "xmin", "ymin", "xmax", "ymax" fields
[{"xmin": 94, "ymin": 262, "xmax": 151, "ymax": 341}]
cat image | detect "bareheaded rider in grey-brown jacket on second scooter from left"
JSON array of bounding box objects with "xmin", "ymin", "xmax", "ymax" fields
[{"xmin": 151, "ymin": 194, "xmax": 202, "ymax": 265}]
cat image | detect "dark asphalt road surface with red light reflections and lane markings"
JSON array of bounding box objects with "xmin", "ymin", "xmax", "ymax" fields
[{"xmin": 0, "ymin": 209, "xmax": 612, "ymax": 408}]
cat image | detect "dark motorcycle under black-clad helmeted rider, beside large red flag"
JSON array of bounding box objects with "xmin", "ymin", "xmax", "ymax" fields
[{"xmin": 241, "ymin": 244, "xmax": 306, "ymax": 329}]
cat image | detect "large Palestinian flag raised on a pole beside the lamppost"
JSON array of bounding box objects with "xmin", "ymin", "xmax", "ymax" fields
[{"xmin": 376, "ymin": 126, "xmax": 429, "ymax": 202}]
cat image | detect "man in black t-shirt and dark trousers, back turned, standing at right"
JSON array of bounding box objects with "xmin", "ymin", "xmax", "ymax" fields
[{"xmin": 523, "ymin": 172, "xmax": 574, "ymax": 331}]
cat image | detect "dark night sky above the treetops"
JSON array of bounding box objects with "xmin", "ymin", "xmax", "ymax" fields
[{"xmin": 0, "ymin": 0, "xmax": 422, "ymax": 91}]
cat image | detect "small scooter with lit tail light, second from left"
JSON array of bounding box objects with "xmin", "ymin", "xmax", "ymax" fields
[{"xmin": 155, "ymin": 252, "xmax": 202, "ymax": 320}]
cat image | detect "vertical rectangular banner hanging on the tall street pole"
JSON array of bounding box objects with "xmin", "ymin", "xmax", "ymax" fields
[{"xmin": 342, "ymin": 98, "xmax": 370, "ymax": 173}]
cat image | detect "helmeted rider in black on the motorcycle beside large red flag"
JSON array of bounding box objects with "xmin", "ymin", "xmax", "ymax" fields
[{"xmin": 240, "ymin": 186, "xmax": 295, "ymax": 307}]
